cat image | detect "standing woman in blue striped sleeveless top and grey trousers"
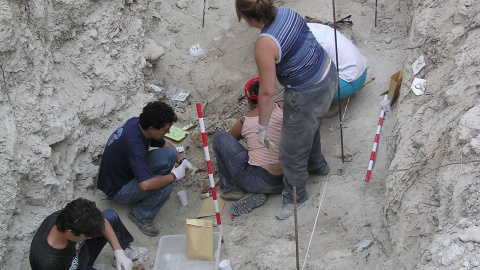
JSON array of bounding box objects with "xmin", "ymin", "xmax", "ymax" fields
[{"xmin": 235, "ymin": 0, "xmax": 337, "ymax": 219}]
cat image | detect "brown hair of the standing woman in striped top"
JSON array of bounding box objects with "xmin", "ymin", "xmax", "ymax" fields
[{"xmin": 235, "ymin": 0, "xmax": 277, "ymax": 26}]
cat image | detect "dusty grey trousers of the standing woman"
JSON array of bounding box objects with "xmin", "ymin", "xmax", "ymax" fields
[{"xmin": 279, "ymin": 62, "xmax": 338, "ymax": 203}]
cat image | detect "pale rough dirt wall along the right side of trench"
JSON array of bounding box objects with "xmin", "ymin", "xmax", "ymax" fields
[{"xmin": 385, "ymin": 1, "xmax": 480, "ymax": 269}]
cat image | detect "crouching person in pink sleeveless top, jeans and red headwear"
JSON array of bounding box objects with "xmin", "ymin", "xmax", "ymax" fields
[{"xmin": 213, "ymin": 77, "xmax": 283, "ymax": 216}]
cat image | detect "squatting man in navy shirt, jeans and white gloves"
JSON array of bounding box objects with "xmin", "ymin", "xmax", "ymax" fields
[{"xmin": 97, "ymin": 101, "xmax": 195, "ymax": 236}]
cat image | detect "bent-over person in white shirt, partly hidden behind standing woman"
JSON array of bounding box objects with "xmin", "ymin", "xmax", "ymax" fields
[{"xmin": 307, "ymin": 23, "xmax": 368, "ymax": 100}]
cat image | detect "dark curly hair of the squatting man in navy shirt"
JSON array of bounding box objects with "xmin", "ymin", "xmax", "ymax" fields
[{"xmin": 139, "ymin": 101, "xmax": 177, "ymax": 130}]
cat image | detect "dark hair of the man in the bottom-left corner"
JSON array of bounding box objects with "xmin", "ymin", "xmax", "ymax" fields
[{"xmin": 55, "ymin": 198, "xmax": 105, "ymax": 237}]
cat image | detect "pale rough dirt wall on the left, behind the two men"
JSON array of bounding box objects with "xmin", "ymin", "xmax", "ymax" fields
[{"xmin": 0, "ymin": 1, "xmax": 153, "ymax": 269}]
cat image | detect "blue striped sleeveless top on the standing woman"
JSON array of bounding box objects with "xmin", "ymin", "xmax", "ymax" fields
[{"xmin": 260, "ymin": 7, "xmax": 328, "ymax": 91}]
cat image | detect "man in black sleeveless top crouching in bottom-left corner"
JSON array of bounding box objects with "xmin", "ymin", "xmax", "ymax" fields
[{"xmin": 29, "ymin": 198, "xmax": 148, "ymax": 270}]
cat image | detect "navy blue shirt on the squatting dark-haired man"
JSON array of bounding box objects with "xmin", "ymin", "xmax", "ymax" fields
[{"xmin": 97, "ymin": 117, "xmax": 165, "ymax": 197}]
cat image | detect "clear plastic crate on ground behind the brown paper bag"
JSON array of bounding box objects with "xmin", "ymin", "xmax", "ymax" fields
[{"xmin": 153, "ymin": 232, "xmax": 222, "ymax": 270}]
